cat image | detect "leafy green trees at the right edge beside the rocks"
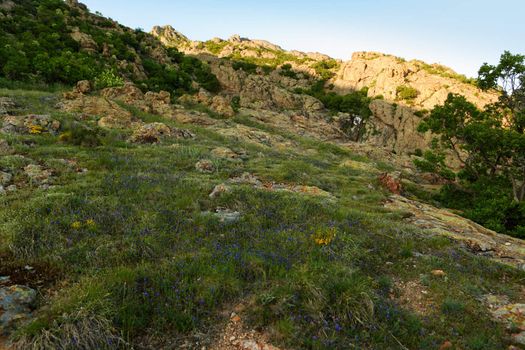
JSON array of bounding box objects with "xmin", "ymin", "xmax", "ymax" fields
[{"xmin": 419, "ymin": 52, "xmax": 525, "ymax": 234}]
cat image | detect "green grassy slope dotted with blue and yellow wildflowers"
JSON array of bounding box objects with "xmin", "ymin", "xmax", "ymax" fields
[{"xmin": 0, "ymin": 90, "xmax": 524, "ymax": 349}]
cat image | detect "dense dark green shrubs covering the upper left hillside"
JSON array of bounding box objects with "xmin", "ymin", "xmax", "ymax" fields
[{"xmin": 0, "ymin": 0, "xmax": 220, "ymax": 95}]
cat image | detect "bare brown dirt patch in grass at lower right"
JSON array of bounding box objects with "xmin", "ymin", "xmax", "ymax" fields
[{"xmin": 391, "ymin": 280, "xmax": 434, "ymax": 316}]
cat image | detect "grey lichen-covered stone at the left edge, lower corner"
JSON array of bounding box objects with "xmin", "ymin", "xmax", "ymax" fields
[{"xmin": 0, "ymin": 285, "xmax": 36, "ymax": 335}]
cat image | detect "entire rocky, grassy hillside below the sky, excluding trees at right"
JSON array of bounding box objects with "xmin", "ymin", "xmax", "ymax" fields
[{"xmin": 0, "ymin": 0, "xmax": 525, "ymax": 350}]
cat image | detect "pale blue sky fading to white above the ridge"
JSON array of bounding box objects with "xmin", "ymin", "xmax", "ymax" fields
[{"xmin": 81, "ymin": 0, "xmax": 525, "ymax": 77}]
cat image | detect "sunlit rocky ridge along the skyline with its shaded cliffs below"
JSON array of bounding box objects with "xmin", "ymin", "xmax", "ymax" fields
[{"xmin": 152, "ymin": 26, "xmax": 498, "ymax": 152}]
